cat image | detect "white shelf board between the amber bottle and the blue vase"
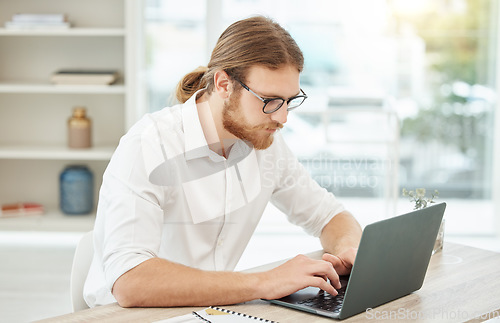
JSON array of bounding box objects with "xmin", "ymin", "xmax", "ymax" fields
[{"xmin": 0, "ymin": 145, "xmax": 116, "ymax": 161}]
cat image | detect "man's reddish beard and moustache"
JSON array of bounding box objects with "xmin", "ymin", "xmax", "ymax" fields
[{"xmin": 222, "ymin": 92, "xmax": 283, "ymax": 150}]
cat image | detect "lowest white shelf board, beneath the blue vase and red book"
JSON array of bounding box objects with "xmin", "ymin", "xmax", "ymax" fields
[{"xmin": 0, "ymin": 211, "xmax": 95, "ymax": 232}]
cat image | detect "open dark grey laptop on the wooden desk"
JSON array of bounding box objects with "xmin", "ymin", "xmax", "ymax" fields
[{"xmin": 268, "ymin": 203, "xmax": 446, "ymax": 319}]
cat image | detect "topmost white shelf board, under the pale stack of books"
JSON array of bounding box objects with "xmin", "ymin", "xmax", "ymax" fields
[{"xmin": 0, "ymin": 28, "xmax": 125, "ymax": 37}]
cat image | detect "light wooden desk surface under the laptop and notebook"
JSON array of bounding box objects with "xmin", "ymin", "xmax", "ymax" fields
[{"xmin": 40, "ymin": 243, "xmax": 500, "ymax": 323}]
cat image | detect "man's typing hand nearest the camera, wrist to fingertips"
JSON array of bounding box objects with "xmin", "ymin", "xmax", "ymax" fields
[{"xmin": 262, "ymin": 255, "xmax": 341, "ymax": 299}]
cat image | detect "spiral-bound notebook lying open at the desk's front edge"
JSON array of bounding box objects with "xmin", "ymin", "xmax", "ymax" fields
[{"xmin": 154, "ymin": 306, "xmax": 278, "ymax": 323}]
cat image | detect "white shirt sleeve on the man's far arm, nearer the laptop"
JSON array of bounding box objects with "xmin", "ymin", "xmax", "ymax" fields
[{"xmin": 271, "ymin": 136, "xmax": 345, "ymax": 237}]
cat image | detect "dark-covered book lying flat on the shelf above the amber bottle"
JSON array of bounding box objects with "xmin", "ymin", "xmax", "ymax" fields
[{"xmin": 50, "ymin": 69, "xmax": 118, "ymax": 85}]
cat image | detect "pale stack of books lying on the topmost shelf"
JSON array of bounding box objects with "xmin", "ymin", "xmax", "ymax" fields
[{"xmin": 5, "ymin": 13, "xmax": 71, "ymax": 30}]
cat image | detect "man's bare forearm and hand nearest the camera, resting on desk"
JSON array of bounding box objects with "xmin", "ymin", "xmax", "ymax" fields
[{"xmin": 112, "ymin": 255, "xmax": 340, "ymax": 307}]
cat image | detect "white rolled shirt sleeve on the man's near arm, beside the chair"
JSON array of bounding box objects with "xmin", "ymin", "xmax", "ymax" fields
[{"xmin": 96, "ymin": 120, "xmax": 164, "ymax": 290}]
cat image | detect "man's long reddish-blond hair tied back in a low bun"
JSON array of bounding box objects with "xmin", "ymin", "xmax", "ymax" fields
[{"xmin": 176, "ymin": 16, "xmax": 304, "ymax": 103}]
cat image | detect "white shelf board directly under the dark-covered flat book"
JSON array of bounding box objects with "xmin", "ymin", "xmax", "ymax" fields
[{"xmin": 0, "ymin": 82, "xmax": 125, "ymax": 94}]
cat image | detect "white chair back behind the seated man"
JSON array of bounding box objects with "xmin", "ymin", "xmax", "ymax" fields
[{"xmin": 70, "ymin": 231, "xmax": 94, "ymax": 312}]
